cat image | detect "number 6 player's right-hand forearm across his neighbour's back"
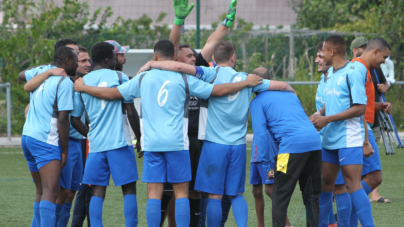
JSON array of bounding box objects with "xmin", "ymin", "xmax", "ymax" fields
[{"xmin": 210, "ymin": 74, "xmax": 262, "ymax": 96}]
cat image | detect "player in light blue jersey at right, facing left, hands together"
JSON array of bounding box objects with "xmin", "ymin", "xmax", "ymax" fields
[{"xmin": 313, "ymin": 35, "xmax": 374, "ymax": 226}]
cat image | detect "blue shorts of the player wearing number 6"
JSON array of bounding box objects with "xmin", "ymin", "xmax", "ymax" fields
[{"xmin": 142, "ymin": 150, "xmax": 192, "ymax": 184}]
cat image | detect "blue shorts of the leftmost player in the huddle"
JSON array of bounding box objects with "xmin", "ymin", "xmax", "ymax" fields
[{"xmin": 21, "ymin": 135, "xmax": 60, "ymax": 172}]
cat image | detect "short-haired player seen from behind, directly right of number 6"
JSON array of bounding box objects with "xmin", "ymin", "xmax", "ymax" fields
[{"xmin": 136, "ymin": 41, "xmax": 294, "ymax": 226}]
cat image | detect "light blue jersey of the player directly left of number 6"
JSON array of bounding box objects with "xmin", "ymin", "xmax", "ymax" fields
[{"xmin": 71, "ymin": 69, "xmax": 133, "ymax": 153}]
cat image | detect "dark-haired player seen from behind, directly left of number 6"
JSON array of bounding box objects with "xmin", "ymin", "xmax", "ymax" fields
[{"xmin": 71, "ymin": 42, "xmax": 138, "ymax": 226}]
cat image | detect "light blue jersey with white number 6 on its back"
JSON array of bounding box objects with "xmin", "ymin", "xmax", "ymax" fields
[{"xmin": 118, "ymin": 69, "xmax": 213, "ymax": 152}]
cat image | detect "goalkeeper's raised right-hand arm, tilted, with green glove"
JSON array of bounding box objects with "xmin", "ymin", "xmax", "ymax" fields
[{"xmin": 200, "ymin": 0, "xmax": 237, "ymax": 62}]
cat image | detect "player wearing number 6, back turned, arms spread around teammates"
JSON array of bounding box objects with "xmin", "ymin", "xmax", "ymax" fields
[{"xmin": 75, "ymin": 40, "xmax": 262, "ymax": 227}]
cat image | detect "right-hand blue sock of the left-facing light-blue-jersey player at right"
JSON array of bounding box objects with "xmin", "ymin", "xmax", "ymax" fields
[{"xmin": 351, "ymin": 189, "xmax": 375, "ymax": 227}]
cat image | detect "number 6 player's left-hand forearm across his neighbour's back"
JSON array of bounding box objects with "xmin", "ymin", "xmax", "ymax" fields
[{"xmin": 74, "ymin": 78, "xmax": 123, "ymax": 100}]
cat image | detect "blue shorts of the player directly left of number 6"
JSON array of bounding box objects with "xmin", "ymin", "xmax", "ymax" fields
[{"xmin": 83, "ymin": 146, "xmax": 139, "ymax": 186}]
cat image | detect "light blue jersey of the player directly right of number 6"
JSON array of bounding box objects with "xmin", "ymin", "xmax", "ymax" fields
[{"xmin": 196, "ymin": 66, "xmax": 270, "ymax": 145}]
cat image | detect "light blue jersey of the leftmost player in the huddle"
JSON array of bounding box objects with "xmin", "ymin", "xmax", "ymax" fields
[{"xmin": 22, "ymin": 66, "xmax": 73, "ymax": 146}]
